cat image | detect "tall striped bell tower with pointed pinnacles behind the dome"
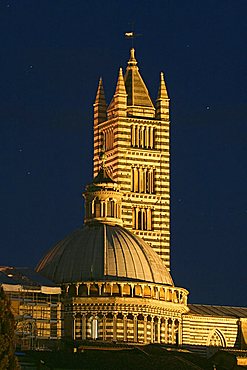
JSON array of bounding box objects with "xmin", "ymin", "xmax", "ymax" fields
[{"xmin": 91, "ymin": 48, "xmax": 170, "ymax": 269}]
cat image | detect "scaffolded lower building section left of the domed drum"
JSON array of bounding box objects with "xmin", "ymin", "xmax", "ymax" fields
[{"xmin": 0, "ymin": 266, "xmax": 62, "ymax": 350}]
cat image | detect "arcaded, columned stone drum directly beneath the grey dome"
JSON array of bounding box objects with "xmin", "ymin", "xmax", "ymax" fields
[{"xmin": 64, "ymin": 281, "xmax": 188, "ymax": 345}]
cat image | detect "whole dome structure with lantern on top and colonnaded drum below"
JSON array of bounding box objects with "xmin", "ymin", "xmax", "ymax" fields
[{"xmin": 37, "ymin": 168, "xmax": 188, "ymax": 345}]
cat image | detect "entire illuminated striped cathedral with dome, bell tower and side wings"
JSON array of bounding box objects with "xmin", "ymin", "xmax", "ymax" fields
[{"xmin": 0, "ymin": 48, "xmax": 247, "ymax": 365}]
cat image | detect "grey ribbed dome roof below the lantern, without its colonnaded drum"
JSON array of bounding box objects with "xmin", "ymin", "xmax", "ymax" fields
[{"xmin": 36, "ymin": 223, "xmax": 173, "ymax": 285}]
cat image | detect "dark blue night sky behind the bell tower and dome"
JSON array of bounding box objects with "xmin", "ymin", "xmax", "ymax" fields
[{"xmin": 0, "ymin": 0, "xmax": 247, "ymax": 306}]
